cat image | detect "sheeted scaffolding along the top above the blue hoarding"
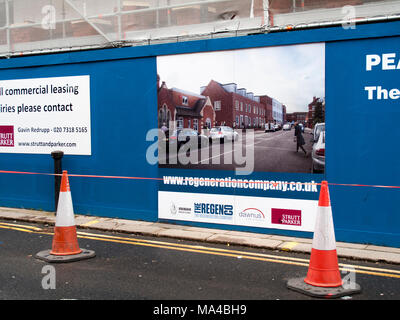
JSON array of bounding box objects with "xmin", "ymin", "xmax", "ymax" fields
[{"xmin": 0, "ymin": 0, "xmax": 400, "ymax": 57}]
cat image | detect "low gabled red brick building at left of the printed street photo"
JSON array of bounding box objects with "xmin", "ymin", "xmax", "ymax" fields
[{"xmin": 157, "ymin": 76, "xmax": 215, "ymax": 133}]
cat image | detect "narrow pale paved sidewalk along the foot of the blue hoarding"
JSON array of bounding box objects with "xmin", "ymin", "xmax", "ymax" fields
[{"xmin": 0, "ymin": 207, "xmax": 400, "ymax": 264}]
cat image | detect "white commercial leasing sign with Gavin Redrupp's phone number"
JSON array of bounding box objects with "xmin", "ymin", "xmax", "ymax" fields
[{"xmin": 0, "ymin": 76, "xmax": 91, "ymax": 155}]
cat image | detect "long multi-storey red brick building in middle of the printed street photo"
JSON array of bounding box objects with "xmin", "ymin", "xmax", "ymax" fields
[{"xmin": 200, "ymin": 80, "xmax": 272, "ymax": 128}]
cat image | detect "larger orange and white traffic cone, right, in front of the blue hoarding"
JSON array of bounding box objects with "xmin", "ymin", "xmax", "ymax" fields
[{"xmin": 287, "ymin": 181, "xmax": 361, "ymax": 298}]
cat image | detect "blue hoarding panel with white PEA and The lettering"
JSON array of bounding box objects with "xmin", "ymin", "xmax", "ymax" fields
[{"xmin": 326, "ymin": 37, "xmax": 400, "ymax": 246}]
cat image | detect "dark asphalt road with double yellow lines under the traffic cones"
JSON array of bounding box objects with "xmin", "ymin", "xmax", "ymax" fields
[{"xmin": 0, "ymin": 221, "xmax": 400, "ymax": 303}]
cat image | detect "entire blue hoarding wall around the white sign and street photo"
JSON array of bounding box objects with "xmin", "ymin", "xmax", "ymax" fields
[{"xmin": 0, "ymin": 22, "xmax": 400, "ymax": 246}]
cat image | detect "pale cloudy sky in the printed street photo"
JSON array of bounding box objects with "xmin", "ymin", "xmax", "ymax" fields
[{"xmin": 157, "ymin": 43, "xmax": 325, "ymax": 113}]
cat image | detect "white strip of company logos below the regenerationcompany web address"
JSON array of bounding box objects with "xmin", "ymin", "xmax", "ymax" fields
[{"xmin": 158, "ymin": 191, "xmax": 318, "ymax": 232}]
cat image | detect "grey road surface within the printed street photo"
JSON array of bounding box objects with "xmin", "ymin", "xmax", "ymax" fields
[{"xmin": 160, "ymin": 130, "xmax": 312, "ymax": 173}]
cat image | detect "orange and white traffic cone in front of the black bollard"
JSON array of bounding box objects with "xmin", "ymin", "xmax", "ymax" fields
[{"xmin": 36, "ymin": 170, "xmax": 95, "ymax": 262}]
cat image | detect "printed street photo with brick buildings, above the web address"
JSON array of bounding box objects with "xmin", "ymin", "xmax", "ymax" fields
[{"xmin": 157, "ymin": 43, "xmax": 325, "ymax": 174}]
